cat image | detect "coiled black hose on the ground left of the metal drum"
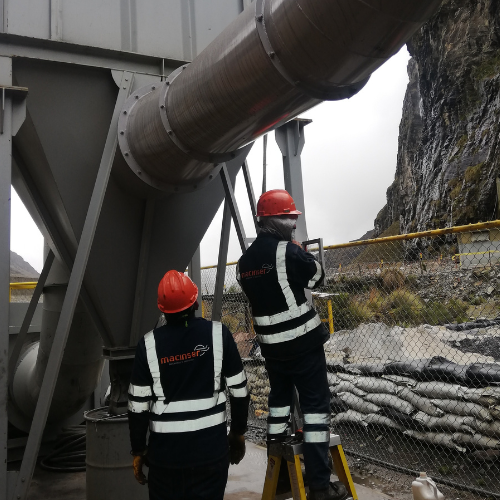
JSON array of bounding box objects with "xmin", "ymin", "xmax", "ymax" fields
[{"xmin": 40, "ymin": 425, "xmax": 86, "ymax": 472}]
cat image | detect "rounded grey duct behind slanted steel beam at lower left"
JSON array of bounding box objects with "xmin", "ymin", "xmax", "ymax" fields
[{"xmin": 9, "ymin": 259, "xmax": 103, "ymax": 431}]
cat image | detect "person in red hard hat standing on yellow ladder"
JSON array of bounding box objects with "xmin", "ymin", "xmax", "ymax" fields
[{"xmin": 237, "ymin": 189, "xmax": 349, "ymax": 500}]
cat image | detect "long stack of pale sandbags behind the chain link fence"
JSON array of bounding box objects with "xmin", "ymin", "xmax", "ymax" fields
[{"xmin": 328, "ymin": 358, "xmax": 500, "ymax": 451}]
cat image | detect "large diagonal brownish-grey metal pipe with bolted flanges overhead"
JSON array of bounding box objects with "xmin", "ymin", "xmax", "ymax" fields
[{"xmin": 119, "ymin": 0, "xmax": 441, "ymax": 190}]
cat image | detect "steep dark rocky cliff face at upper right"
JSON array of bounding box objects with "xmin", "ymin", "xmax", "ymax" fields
[{"xmin": 375, "ymin": 0, "xmax": 500, "ymax": 234}]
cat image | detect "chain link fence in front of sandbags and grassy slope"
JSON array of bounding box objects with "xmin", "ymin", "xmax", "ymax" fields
[{"xmin": 202, "ymin": 223, "xmax": 500, "ymax": 499}]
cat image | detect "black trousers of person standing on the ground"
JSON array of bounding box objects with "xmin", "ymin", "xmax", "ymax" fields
[{"xmin": 148, "ymin": 457, "xmax": 229, "ymax": 500}]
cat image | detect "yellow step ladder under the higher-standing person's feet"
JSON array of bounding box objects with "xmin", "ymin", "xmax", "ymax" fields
[{"xmin": 262, "ymin": 434, "xmax": 358, "ymax": 500}]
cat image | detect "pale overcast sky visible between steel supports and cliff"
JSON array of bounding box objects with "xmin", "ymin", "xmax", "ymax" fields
[{"xmin": 11, "ymin": 47, "xmax": 409, "ymax": 271}]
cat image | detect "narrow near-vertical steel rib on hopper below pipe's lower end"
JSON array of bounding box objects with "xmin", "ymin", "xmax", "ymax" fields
[{"xmin": 129, "ymin": 199, "xmax": 155, "ymax": 346}]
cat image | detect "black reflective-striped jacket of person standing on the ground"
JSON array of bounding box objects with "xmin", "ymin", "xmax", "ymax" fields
[{"xmin": 128, "ymin": 318, "xmax": 249, "ymax": 465}]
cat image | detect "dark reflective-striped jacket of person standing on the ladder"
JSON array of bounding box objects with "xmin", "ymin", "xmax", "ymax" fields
[{"xmin": 237, "ymin": 233, "xmax": 328, "ymax": 359}]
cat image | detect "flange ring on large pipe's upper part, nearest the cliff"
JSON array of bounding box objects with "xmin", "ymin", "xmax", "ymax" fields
[{"xmin": 255, "ymin": 0, "xmax": 370, "ymax": 101}]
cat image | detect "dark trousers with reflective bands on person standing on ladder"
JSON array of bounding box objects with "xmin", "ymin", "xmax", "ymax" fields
[{"xmin": 266, "ymin": 346, "xmax": 331, "ymax": 490}]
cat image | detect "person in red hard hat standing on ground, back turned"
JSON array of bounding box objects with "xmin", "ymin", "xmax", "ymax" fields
[{"xmin": 128, "ymin": 271, "xmax": 249, "ymax": 500}]
